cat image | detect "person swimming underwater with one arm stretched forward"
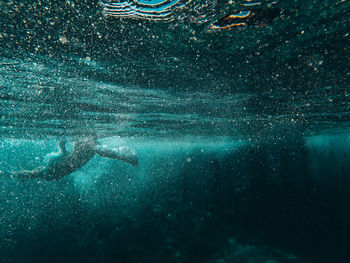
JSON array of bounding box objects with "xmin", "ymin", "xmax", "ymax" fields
[{"xmin": 0, "ymin": 139, "xmax": 139, "ymax": 182}]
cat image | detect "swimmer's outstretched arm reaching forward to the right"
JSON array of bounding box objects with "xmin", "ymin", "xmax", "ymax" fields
[{"xmin": 95, "ymin": 145, "xmax": 139, "ymax": 167}]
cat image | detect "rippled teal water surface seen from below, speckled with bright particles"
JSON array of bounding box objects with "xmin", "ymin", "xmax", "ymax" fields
[{"xmin": 0, "ymin": 0, "xmax": 350, "ymax": 138}]
